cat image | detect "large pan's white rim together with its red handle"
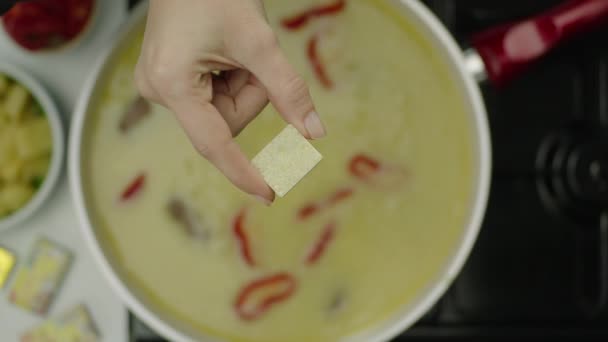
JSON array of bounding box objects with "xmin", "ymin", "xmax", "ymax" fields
[{"xmin": 69, "ymin": 0, "xmax": 608, "ymax": 342}]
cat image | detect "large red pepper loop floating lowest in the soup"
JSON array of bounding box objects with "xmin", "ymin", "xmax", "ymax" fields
[{"xmin": 234, "ymin": 272, "xmax": 297, "ymax": 321}]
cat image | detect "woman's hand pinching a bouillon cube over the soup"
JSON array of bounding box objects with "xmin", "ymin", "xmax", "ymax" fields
[{"xmin": 135, "ymin": 0, "xmax": 325, "ymax": 204}]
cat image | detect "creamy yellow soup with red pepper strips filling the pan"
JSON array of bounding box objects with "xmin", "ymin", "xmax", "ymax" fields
[{"xmin": 84, "ymin": 0, "xmax": 475, "ymax": 342}]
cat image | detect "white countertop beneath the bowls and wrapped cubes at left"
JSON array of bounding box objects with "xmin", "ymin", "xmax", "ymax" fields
[{"xmin": 0, "ymin": 0, "xmax": 128, "ymax": 342}]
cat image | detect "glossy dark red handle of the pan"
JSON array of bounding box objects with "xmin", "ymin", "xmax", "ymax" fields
[{"xmin": 471, "ymin": 0, "xmax": 608, "ymax": 85}]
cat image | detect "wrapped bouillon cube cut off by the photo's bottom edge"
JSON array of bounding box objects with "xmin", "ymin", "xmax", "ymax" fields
[{"xmin": 21, "ymin": 304, "xmax": 100, "ymax": 342}]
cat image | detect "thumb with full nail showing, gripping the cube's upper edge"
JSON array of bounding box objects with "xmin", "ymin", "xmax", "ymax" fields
[{"xmin": 243, "ymin": 37, "xmax": 326, "ymax": 139}]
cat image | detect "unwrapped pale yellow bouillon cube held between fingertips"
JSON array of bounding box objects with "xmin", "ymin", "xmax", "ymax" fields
[{"xmin": 252, "ymin": 125, "xmax": 323, "ymax": 197}]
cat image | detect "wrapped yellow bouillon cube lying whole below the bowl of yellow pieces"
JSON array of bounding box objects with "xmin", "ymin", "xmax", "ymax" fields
[{"xmin": 10, "ymin": 238, "xmax": 72, "ymax": 314}]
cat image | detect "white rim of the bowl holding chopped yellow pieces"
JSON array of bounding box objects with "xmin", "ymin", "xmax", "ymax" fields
[{"xmin": 0, "ymin": 61, "xmax": 65, "ymax": 232}]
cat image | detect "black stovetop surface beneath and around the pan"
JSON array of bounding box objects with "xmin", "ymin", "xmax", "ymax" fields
[{"xmin": 127, "ymin": 0, "xmax": 608, "ymax": 341}]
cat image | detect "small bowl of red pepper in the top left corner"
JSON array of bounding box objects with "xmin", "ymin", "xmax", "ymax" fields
[{"xmin": 2, "ymin": 0, "xmax": 98, "ymax": 52}]
